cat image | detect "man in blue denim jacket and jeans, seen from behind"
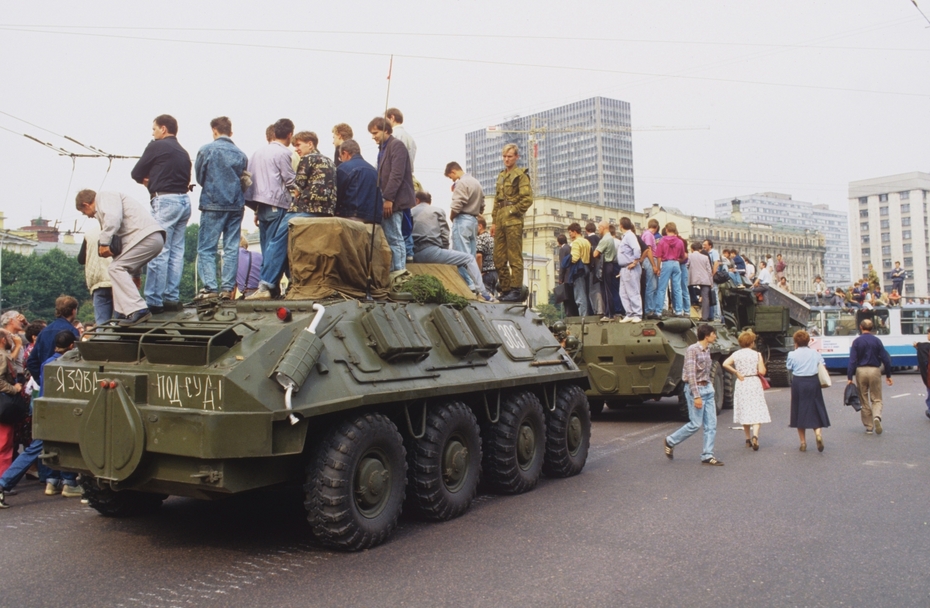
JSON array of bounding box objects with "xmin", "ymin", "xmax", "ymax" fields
[{"xmin": 194, "ymin": 116, "xmax": 249, "ymax": 299}]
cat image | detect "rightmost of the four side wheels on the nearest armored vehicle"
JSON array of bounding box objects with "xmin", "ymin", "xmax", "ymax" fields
[{"xmin": 543, "ymin": 384, "xmax": 591, "ymax": 477}]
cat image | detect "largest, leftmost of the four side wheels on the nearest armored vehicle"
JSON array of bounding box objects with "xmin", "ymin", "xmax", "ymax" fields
[{"xmin": 304, "ymin": 414, "xmax": 407, "ymax": 551}]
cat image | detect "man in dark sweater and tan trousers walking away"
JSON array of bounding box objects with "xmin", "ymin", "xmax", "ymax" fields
[{"xmin": 846, "ymin": 319, "xmax": 894, "ymax": 435}]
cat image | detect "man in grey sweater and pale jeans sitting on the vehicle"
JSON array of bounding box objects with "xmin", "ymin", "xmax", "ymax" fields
[{"xmin": 410, "ymin": 192, "xmax": 494, "ymax": 302}]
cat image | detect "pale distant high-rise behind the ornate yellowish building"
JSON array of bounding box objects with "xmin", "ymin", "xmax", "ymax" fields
[{"xmin": 714, "ymin": 192, "xmax": 852, "ymax": 286}]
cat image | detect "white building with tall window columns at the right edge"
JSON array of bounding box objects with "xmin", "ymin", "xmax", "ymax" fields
[{"xmin": 849, "ymin": 171, "xmax": 930, "ymax": 298}]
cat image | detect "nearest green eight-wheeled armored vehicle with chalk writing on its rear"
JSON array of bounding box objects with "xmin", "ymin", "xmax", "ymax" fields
[{"xmin": 33, "ymin": 218, "xmax": 591, "ymax": 550}]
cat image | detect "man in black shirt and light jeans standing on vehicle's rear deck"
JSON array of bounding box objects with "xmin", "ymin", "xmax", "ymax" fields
[{"xmin": 132, "ymin": 114, "xmax": 191, "ymax": 313}]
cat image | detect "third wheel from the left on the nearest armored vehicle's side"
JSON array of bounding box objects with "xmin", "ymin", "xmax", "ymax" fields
[{"xmin": 482, "ymin": 391, "xmax": 546, "ymax": 494}]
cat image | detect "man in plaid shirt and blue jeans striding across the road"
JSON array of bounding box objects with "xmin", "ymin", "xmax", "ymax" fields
[{"xmin": 665, "ymin": 325, "xmax": 723, "ymax": 467}]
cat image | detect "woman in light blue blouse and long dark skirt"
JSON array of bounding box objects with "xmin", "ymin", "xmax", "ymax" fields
[{"xmin": 787, "ymin": 329, "xmax": 830, "ymax": 452}]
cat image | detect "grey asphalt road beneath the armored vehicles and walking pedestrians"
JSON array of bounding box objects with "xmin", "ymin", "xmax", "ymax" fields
[{"xmin": 0, "ymin": 374, "xmax": 930, "ymax": 608}]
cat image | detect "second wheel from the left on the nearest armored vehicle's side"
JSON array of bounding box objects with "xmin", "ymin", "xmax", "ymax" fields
[{"xmin": 405, "ymin": 401, "xmax": 481, "ymax": 521}]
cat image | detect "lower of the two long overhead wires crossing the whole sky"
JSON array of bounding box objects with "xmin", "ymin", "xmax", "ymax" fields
[{"xmin": 0, "ymin": 27, "xmax": 930, "ymax": 97}]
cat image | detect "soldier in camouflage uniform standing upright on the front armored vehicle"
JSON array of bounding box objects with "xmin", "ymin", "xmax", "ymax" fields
[{"xmin": 491, "ymin": 144, "xmax": 533, "ymax": 302}]
